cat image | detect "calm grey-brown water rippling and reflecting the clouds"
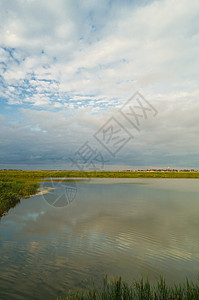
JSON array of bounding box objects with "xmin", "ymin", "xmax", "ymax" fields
[{"xmin": 0, "ymin": 179, "xmax": 199, "ymax": 300}]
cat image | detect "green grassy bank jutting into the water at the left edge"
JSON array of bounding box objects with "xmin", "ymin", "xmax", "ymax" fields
[{"xmin": 0, "ymin": 176, "xmax": 39, "ymax": 217}]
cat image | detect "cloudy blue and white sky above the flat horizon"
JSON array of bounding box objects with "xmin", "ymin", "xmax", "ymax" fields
[{"xmin": 0, "ymin": 0, "xmax": 199, "ymax": 170}]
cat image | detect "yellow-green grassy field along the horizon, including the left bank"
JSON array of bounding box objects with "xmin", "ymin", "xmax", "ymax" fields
[{"xmin": 0, "ymin": 170, "xmax": 199, "ymax": 217}]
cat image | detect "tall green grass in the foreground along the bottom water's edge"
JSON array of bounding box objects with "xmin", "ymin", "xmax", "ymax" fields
[{"xmin": 57, "ymin": 276, "xmax": 199, "ymax": 300}]
